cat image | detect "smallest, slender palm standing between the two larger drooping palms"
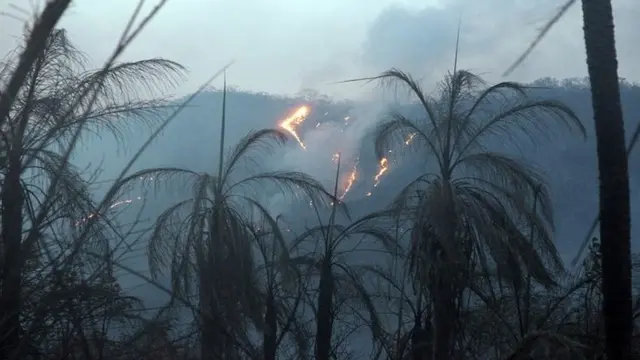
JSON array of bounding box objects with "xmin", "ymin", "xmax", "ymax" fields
[{"xmin": 290, "ymin": 158, "xmax": 395, "ymax": 360}]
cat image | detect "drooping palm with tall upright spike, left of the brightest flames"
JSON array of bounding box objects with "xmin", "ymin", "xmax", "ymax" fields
[{"xmin": 119, "ymin": 80, "xmax": 333, "ymax": 359}]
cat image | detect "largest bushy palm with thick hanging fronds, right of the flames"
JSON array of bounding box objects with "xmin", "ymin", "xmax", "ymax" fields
[{"xmin": 364, "ymin": 69, "xmax": 584, "ymax": 360}]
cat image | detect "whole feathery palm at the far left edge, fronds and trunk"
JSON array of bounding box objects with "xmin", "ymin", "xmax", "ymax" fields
[{"xmin": 0, "ymin": 26, "xmax": 182, "ymax": 358}]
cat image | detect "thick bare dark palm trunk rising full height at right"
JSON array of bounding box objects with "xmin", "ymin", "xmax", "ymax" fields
[{"xmin": 582, "ymin": 0, "xmax": 633, "ymax": 360}]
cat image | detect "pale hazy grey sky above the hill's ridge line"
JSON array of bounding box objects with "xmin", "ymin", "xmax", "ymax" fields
[{"xmin": 0, "ymin": 0, "xmax": 640, "ymax": 96}]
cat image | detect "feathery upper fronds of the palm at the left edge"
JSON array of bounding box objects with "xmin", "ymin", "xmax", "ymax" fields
[{"xmin": 6, "ymin": 30, "xmax": 184, "ymax": 152}]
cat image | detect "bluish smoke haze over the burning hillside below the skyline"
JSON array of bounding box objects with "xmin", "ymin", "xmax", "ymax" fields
[{"xmin": 66, "ymin": 79, "xmax": 640, "ymax": 338}]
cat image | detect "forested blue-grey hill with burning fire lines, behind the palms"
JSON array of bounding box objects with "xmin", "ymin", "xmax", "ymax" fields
[{"xmin": 78, "ymin": 79, "xmax": 640, "ymax": 259}]
